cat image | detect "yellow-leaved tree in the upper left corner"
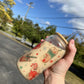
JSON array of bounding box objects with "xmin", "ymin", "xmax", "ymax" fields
[{"xmin": 0, "ymin": 0, "xmax": 15, "ymax": 24}]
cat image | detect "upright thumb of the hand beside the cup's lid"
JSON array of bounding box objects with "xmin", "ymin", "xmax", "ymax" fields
[{"xmin": 64, "ymin": 39, "xmax": 76, "ymax": 65}]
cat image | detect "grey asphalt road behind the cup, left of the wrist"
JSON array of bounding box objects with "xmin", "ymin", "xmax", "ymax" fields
[{"xmin": 0, "ymin": 34, "xmax": 67, "ymax": 84}]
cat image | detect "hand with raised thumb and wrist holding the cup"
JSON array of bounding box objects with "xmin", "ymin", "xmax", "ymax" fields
[{"xmin": 44, "ymin": 39, "xmax": 76, "ymax": 84}]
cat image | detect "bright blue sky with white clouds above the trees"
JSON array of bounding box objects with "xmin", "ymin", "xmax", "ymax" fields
[{"xmin": 6, "ymin": 0, "xmax": 84, "ymax": 35}]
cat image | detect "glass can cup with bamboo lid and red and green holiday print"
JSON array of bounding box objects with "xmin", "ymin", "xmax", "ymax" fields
[{"xmin": 17, "ymin": 33, "xmax": 68, "ymax": 80}]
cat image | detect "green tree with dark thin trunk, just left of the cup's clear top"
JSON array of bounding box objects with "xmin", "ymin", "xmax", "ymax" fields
[{"xmin": 23, "ymin": 19, "xmax": 41, "ymax": 47}]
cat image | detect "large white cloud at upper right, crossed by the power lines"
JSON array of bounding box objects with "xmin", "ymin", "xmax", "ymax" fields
[{"xmin": 48, "ymin": 0, "xmax": 84, "ymax": 33}]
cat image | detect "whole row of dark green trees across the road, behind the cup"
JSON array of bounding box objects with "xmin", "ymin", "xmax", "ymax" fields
[{"xmin": 13, "ymin": 15, "xmax": 56, "ymax": 47}]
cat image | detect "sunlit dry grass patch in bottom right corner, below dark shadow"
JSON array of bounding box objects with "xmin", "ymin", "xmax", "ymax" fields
[{"xmin": 65, "ymin": 71, "xmax": 84, "ymax": 84}]
